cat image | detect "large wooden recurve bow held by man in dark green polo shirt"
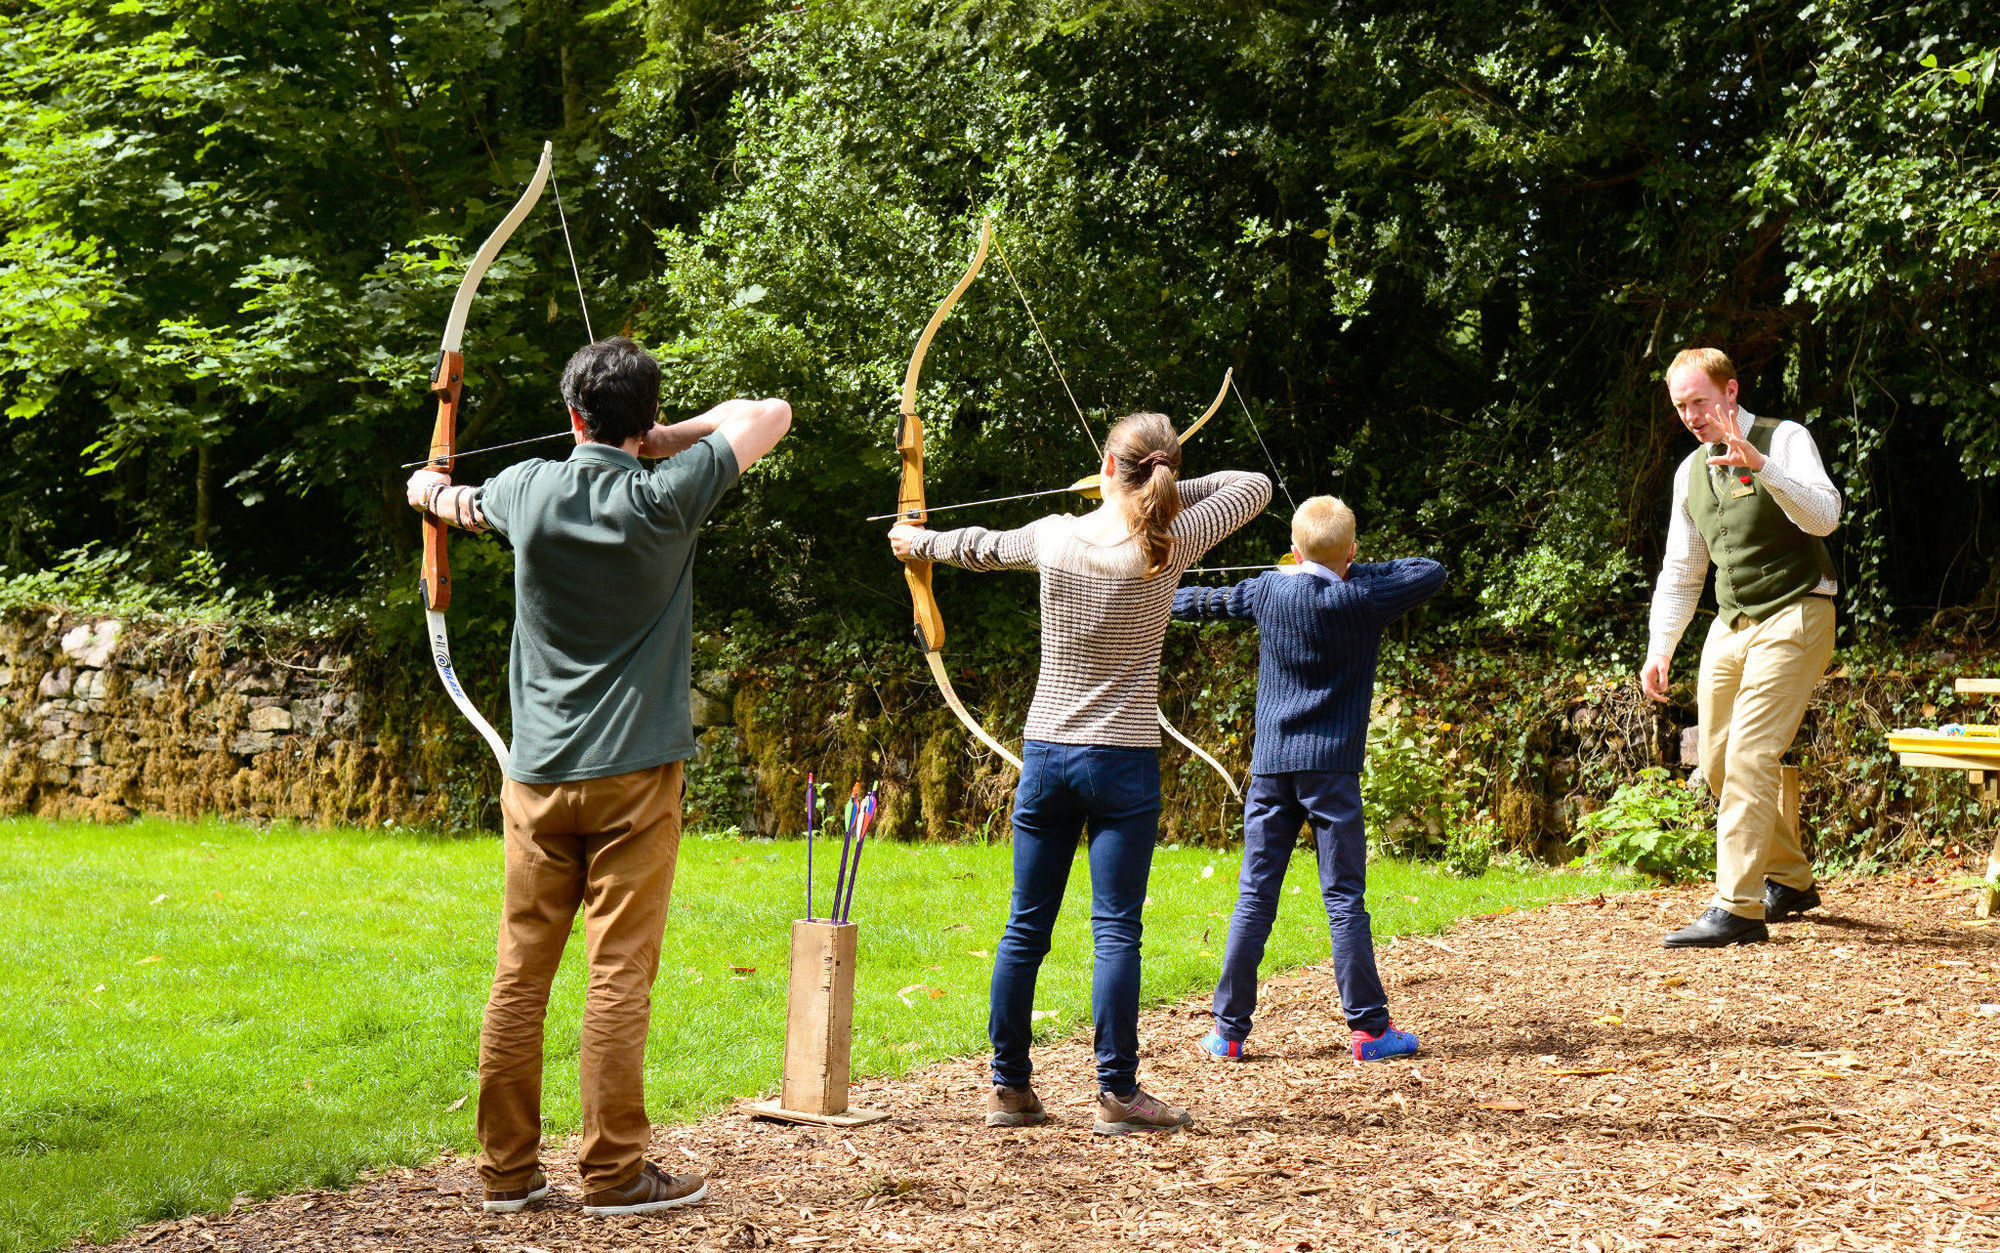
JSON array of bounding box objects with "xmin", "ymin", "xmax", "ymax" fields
[{"xmin": 416, "ymin": 144, "xmax": 556, "ymax": 775}]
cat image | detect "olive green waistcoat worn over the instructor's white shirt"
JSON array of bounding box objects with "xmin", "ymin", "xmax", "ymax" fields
[{"xmin": 1686, "ymin": 418, "xmax": 1834, "ymax": 622}]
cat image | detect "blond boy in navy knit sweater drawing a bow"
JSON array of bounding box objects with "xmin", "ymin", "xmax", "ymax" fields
[{"xmin": 1174, "ymin": 496, "xmax": 1444, "ymax": 1061}]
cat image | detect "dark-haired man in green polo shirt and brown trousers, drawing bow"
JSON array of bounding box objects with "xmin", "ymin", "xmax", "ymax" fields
[{"xmin": 408, "ymin": 338, "xmax": 792, "ymax": 1217}]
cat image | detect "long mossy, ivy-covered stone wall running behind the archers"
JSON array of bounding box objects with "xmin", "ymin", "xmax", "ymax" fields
[{"xmin": 11, "ymin": 608, "xmax": 2000, "ymax": 865}]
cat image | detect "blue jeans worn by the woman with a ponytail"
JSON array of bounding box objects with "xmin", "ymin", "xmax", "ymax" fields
[{"xmin": 986, "ymin": 741, "xmax": 1160, "ymax": 1097}]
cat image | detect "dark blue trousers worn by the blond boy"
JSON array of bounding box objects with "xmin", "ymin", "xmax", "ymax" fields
[{"xmin": 1216, "ymin": 771, "xmax": 1388, "ymax": 1041}]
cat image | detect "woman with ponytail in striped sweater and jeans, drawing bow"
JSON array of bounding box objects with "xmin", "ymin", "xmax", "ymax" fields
[{"xmin": 890, "ymin": 414, "xmax": 1270, "ymax": 1135}]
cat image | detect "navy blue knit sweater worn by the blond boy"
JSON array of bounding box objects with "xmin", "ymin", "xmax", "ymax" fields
[{"xmin": 1174, "ymin": 556, "xmax": 1444, "ymax": 775}]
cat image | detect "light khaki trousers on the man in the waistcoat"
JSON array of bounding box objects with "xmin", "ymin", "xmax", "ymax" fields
[{"xmin": 1696, "ymin": 596, "xmax": 1834, "ymax": 919}]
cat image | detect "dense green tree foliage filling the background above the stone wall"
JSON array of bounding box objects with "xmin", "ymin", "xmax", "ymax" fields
[{"xmin": 0, "ymin": 0, "xmax": 2000, "ymax": 661}]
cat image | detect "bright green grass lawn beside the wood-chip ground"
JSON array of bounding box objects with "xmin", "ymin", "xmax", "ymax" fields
[{"xmin": 0, "ymin": 821, "xmax": 1622, "ymax": 1251}]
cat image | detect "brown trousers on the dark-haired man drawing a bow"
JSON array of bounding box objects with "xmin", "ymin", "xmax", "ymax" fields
[{"xmin": 478, "ymin": 761, "xmax": 682, "ymax": 1191}]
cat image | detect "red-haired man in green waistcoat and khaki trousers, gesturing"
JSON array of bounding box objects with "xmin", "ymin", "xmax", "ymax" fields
[{"xmin": 1640, "ymin": 348, "xmax": 1840, "ymax": 949}]
